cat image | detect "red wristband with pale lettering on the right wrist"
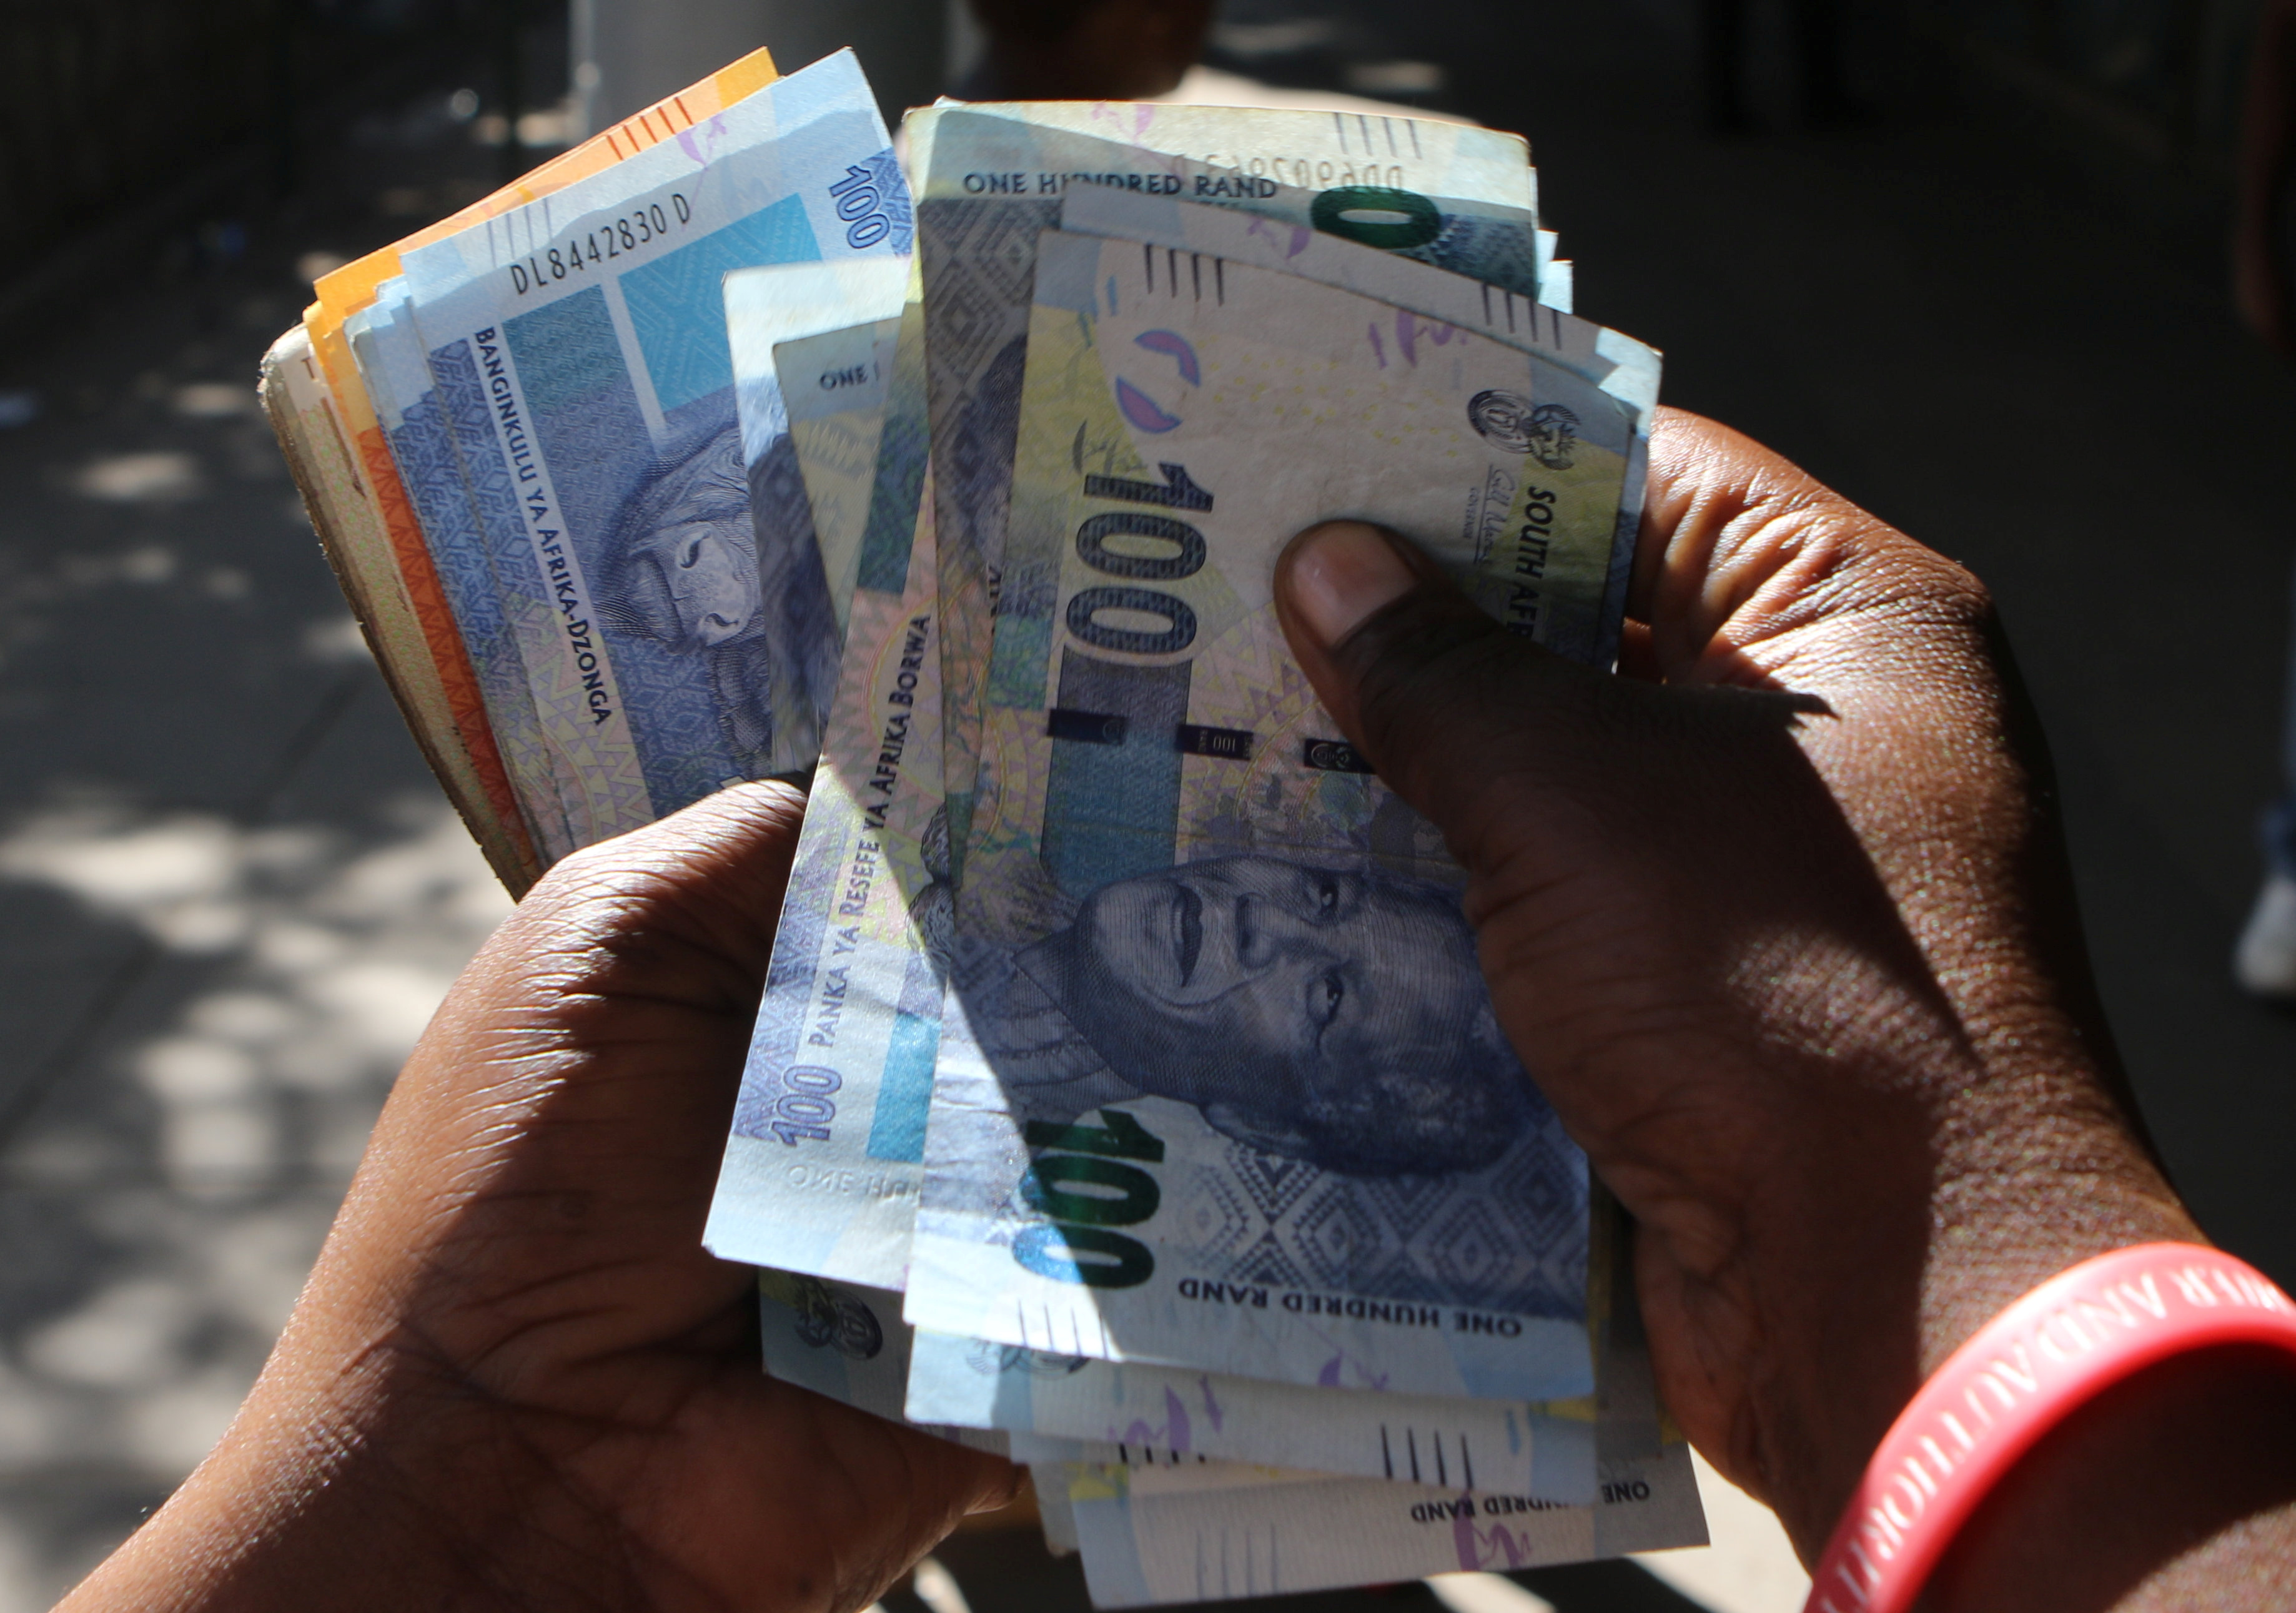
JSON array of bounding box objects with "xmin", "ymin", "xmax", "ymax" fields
[{"xmin": 1804, "ymin": 1243, "xmax": 2296, "ymax": 1613}]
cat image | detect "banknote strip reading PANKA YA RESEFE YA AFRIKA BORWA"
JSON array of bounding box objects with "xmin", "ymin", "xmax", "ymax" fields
[{"xmin": 703, "ymin": 303, "xmax": 951, "ymax": 1290}]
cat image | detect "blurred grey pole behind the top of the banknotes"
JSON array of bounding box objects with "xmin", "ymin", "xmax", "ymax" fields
[{"xmin": 570, "ymin": 0, "xmax": 962, "ymax": 140}]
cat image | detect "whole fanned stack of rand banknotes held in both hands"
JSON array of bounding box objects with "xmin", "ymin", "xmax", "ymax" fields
[{"xmin": 266, "ymin": 37, "xmax": 1704, "ymax": 1606}]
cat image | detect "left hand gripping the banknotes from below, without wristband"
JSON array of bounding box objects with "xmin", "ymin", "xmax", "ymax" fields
[{"xmin": 67, "ymin": 785, "xmax": 1017, "ymax": 1613}]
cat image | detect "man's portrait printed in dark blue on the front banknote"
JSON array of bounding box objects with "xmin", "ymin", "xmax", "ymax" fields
[{"xmin": 953, "ymin": 854, "xmax": 1541, "ymax": 1177}]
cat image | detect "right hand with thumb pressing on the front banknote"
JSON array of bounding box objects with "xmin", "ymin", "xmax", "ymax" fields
[{"xmin": 1279, "ymin": 411, "xmax": 2197, "ymax": 1556}]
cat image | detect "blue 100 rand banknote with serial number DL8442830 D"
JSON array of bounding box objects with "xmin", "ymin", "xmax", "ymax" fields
[{"xmin": 407, "ymin": 53, "xmax": 911, "ymax": 858}]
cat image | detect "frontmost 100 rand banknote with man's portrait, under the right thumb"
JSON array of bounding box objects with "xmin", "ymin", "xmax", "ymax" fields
[{"xmin": 907, "ymin": 232, "xmax": 1635, "ymax": 1399}]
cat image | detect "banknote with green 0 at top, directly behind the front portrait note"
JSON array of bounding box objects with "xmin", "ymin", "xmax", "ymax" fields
[{"xmin": 907, "ymin": 103, "xmax": 1538, "ymax": 884}]
